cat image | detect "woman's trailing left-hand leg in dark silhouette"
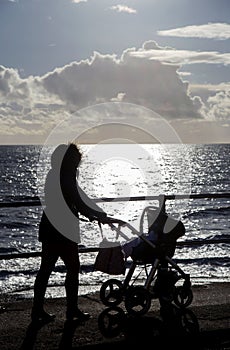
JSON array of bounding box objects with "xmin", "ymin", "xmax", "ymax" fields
[{"xmin": 31, "ymin": 242, "xmax": 58, "ymax": 318}]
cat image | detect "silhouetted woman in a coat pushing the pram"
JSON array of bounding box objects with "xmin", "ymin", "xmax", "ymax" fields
[{"xmin": 31, "ymin": 143, "xmax": 108, "ymax": 322}]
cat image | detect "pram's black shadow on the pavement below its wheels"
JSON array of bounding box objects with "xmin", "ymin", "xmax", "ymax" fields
[{"xmin": 94, "ymin": 305, "xmax": 230, "ymax": 350}]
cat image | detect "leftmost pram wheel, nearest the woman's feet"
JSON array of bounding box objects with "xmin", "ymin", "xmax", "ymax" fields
[{"xmin": 100, "ymin": 278, "xmax": 123, "ymax": 306}]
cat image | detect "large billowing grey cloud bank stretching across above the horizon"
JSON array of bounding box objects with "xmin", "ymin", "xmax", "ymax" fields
[{"xmin": 0, "ymin": 41, "xmax": 229, "ymax": 143}]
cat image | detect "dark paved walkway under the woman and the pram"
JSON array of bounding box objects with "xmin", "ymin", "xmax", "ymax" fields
[{"xmin": 0, "ymin": 283, "xmax": 230, "ymax": 350}]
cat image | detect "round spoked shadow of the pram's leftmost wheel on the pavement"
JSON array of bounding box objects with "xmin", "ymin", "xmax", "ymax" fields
[{"xmin": 98, "ymin": 306, "xmax": 125, "ymax": 338}]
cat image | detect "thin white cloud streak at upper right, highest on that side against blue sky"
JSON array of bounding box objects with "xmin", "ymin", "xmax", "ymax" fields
[{"xmin": 157, "ymin": 23, "xmax": 230, "ymax": 40}]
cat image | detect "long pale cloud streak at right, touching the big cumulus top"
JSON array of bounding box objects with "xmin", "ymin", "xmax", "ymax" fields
[{"xmin": 132, "ymin": 41, "xmax": 230, "ymax": 65}]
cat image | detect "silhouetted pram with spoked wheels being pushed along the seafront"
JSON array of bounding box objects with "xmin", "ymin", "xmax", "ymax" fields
[{"xmin": 100, "ymin": 206, "xmax": 193, "ymax": 316}]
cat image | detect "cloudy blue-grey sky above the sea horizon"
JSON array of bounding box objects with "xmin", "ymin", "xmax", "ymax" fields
[{"xmin": 0, "ymin": 0, "xmax": 230, "ymax": 144}]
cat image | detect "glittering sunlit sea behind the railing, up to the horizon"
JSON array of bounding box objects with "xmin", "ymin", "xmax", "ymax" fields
[{"xmin": 0, "ymin": 144, "xmax": 230, "ymax": 298}]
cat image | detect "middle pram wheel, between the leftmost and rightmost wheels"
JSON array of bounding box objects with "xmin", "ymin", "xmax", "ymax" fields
[{"xmin": 125, "ymin": 286, "xmax": 151, "ymax": 316}]
